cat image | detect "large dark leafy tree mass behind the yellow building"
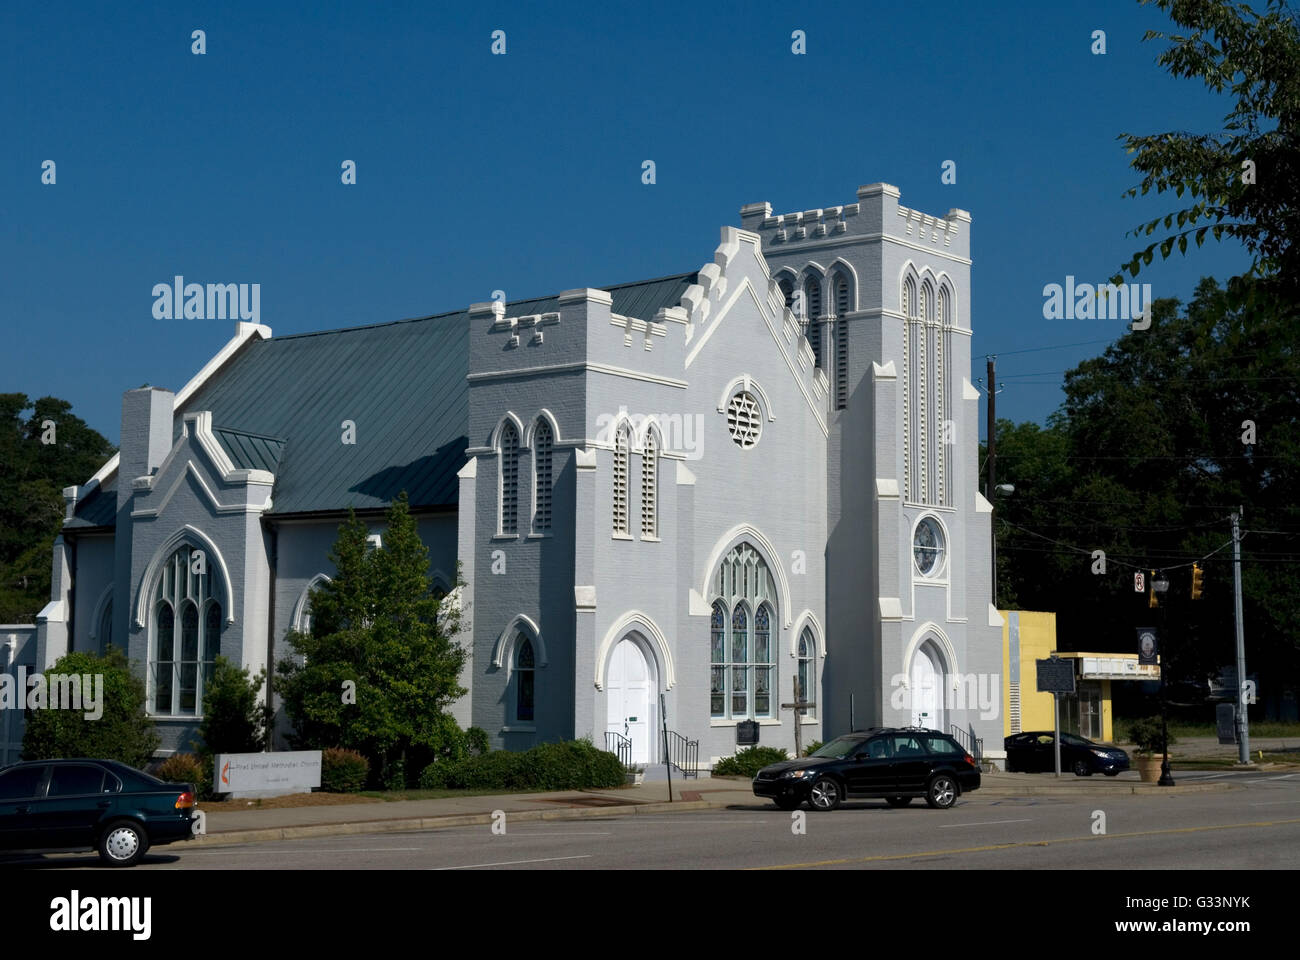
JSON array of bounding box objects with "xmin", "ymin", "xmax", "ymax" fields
[{"xmin": 997, "ymin": 280, "xmax": 1300, "ymax": 692}]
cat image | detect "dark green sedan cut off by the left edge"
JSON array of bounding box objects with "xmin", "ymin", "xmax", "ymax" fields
[{"xmin": 0, "ymin": 760, "xmax": 195, "ymax": 866}]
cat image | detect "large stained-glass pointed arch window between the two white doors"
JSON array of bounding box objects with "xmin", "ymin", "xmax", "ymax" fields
[{"xmin": 709, "ymin": 544, "xmax": 777, "ymax": 719}]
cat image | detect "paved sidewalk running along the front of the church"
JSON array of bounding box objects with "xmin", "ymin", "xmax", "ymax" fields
[{"xmin": 191, "ymin": 773, "xmax": 1235, "ymax": 847}]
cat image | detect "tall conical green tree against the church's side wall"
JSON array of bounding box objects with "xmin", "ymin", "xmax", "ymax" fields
[{"xmin": 277, "ymin": 492, "xmax": 465, "ymax": 783}]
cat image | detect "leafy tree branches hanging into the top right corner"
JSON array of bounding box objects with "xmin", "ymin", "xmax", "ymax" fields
[{"xmin": 1112, "ymin": 0, "xmax": 1300, "ymax": 308}]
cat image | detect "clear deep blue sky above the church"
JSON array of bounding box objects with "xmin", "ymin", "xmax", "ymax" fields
[{"xmin": 0, "ymin": 0, "xmax": 1248, "ymax": 442}]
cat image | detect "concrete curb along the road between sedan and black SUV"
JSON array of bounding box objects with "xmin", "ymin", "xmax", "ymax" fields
[{"xmin": 186, "ymin": 800, "xmax": 729, "ymax": 849}]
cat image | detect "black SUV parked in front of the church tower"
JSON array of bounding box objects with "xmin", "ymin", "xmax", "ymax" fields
[{"xmin": 754, "ymin": 727, "xmax": 979, "ymax": 810}]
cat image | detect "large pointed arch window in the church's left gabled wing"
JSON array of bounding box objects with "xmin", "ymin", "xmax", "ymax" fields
[{"xmin": 148, "ymin": 545, "xmax": 221, "ymax": 717}]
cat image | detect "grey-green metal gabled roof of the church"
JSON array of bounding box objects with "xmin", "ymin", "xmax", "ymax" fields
[{"xmin": 70, "ymin": 273, "xmax": 697, "ymax": 515}]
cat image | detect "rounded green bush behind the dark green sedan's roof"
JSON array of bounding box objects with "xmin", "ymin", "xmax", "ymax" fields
[{"xmin": 22, "ymin": 647, "xmax": 159, "ymax": 769}]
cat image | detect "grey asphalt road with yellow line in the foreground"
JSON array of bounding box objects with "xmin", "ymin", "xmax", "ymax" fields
[{"xmin": 0, "ymin": 773, "xmax": 1300, "ymax": 872}]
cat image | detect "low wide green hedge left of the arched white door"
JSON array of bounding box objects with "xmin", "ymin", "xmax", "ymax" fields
[{"xmin": 420, "ymin": 738, "xmax": 627, "ymax": 791}]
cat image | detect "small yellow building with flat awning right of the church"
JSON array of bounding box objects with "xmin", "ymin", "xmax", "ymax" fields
[{"xmin": 1000, "ymin": 610, "xmax": 1160, "ymax": 743}]
